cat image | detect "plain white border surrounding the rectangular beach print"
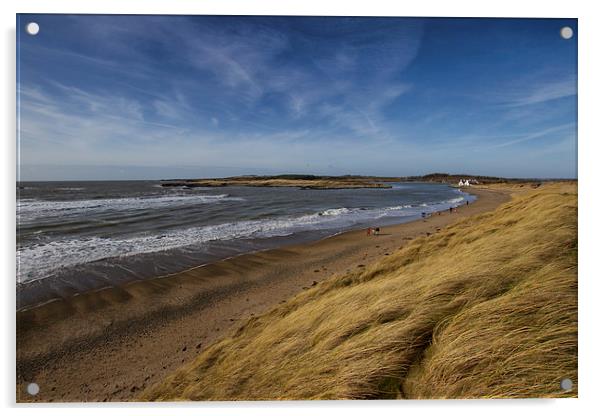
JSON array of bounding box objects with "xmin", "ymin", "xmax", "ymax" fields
[{"xmin": 0, "ymin": 0, "xmax": 602, "ymax": 416}]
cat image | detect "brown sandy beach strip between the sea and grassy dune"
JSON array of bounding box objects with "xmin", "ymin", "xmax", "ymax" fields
[{"xmin": 17, "ymin": 189, "xmax": 510, "ymax": 402}]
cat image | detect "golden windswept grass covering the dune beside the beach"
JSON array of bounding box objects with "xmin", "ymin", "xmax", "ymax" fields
[{"xmin": 141, "ymin": 183, "xmax": 577, "ymax": 400}]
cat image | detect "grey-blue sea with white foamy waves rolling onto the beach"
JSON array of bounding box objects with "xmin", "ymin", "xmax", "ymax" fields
[{"xmin": 17, "ymin": 181, "xmax": 474, "ymax": 308}]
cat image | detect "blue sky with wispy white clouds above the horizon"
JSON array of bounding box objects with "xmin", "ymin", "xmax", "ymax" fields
[{"xmin": 17, "ymin": 14, "xmax": 577, "ymax": 180}]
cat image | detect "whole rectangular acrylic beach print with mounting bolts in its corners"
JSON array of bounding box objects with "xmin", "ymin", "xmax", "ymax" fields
[{"xmin": 16, "ymin": 14, "xmax": 578, "ymax": 402}]
